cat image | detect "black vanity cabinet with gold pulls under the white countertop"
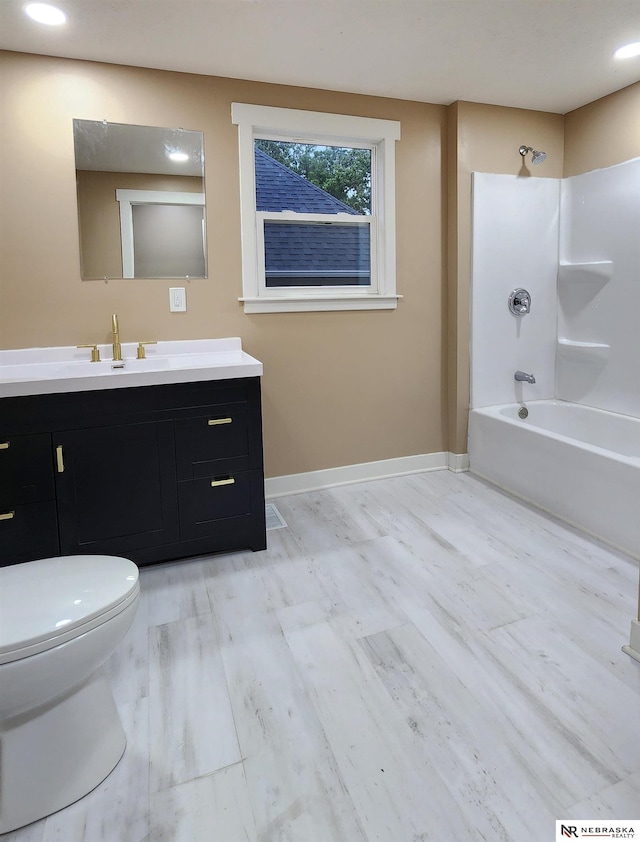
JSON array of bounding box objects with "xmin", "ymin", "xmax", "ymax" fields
[{"xmin": 0, "ymin": 377, "xmax": 266, "ymax": 564}]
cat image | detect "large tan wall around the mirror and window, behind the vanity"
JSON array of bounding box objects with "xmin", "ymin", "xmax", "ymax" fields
[{"xmin": 0, "ymin": 53, "xmax": 447, "ymax": 476}]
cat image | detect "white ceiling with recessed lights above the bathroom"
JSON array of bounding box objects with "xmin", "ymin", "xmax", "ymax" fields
[{"xmin": 0, "ymin": 0, "xmax": 640, "ymax": 114}]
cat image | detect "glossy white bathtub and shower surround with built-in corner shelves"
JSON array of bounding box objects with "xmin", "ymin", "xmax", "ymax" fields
[{"xmin": 469, "ymin": 159, "xmax": 640, "ymax": 658}]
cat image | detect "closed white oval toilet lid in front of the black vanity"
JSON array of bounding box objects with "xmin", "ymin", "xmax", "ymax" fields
[{"xmin": 0, "ymin": 555, "xmax": 138, "ymax": 661}]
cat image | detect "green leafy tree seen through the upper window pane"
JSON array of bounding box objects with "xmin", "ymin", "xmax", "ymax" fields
[{"xmin": 255, "ymin": 140, "xmax": 371, "ymax": 214}]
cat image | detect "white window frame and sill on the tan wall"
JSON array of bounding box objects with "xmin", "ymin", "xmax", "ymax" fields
[{"xmin": 231, "ymin": 102, "xmax": 402, "ymax": 313}]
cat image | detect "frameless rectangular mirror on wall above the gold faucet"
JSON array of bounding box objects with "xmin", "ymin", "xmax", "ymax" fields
[{"xmin": 73, "ymin": 120, "xmax": 207, "ymax": 280}]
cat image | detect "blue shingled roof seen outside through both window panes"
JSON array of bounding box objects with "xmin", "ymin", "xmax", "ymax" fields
[{"xmin": 255, "ymin": 147, "xmax": 370, "ymax": 287}]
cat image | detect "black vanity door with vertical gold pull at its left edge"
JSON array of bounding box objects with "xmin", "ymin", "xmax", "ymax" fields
[{"xmin": 53, "ymin": 421, "xmax": 178, "ymax": 561}]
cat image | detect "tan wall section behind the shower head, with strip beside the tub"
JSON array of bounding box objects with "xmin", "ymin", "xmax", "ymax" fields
[{"xmin": 448, "ymin": 102, "xmax": 564, "ymax": 453}]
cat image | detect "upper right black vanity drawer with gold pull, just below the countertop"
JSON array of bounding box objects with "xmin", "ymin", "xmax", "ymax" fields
[{"xmin": 174, "ymin": 404, "xmax": 251, "ymax": 480}]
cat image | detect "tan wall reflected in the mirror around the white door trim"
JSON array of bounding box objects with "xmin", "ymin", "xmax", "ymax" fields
[{"xmin": 76, "ymin": 170, "xmax": 203, "ymax": 279}]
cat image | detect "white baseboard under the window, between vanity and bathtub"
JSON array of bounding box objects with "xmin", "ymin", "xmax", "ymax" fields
[{"xmin": 264, "ymin": 451, "xmax": 469, "ymax": 500}]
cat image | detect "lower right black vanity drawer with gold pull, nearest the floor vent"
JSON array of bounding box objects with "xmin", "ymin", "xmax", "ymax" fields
[{"xmin": 178, "ymin": 471, "xmax": 264, "ymax": 540}]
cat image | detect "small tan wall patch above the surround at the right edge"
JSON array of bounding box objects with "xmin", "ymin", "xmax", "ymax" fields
[{"xmin": 564, "ymin": 82, "xmax": 640, "ymax": 177}]
